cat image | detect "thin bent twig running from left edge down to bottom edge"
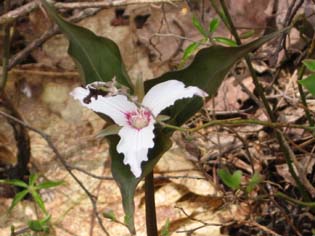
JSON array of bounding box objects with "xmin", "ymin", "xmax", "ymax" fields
[{"xmin": 0, "ymin": 111, "xmax": 110, "ymax": 236}]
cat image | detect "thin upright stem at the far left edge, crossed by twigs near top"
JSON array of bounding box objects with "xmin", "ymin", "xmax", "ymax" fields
[{"xmin": 0, "ymin": 0, "xmax": 10, "ymax": 95}]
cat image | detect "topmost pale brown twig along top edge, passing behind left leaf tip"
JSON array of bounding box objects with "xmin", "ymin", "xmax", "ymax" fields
[{"xmin": 0, "ymin": 0, "xmax": 183, "ymax": 25}]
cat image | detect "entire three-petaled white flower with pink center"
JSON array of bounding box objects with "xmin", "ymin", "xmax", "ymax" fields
[{"xmin": 71, "ymin": 80, "xmax": 208, "ymax": 177}]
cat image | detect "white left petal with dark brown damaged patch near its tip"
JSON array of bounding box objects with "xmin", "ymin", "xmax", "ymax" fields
[{"xmin": 70, "ymin": 87, "xmax": 137, "ymax": 126}]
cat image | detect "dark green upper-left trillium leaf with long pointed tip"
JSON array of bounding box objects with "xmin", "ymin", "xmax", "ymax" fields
[{"xmin": 42, "ymin": 0, "xmax": 132, "ymax": 88}]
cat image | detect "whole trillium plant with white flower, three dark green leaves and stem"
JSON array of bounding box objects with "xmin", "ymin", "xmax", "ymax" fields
[{"xmin": 41, "ymin": 0, "xmax": 279, "ymax": 232}]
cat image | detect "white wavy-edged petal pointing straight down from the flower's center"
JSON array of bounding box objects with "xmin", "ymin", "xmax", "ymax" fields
[{"xmin": 117, "ymin": 122, "xmax": 154, "ymax": 178}]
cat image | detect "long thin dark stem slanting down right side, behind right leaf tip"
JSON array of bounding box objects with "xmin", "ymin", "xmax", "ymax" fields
[{"xmin": 212, "ymin": 0, "xmax": 309, "ymax": 200}]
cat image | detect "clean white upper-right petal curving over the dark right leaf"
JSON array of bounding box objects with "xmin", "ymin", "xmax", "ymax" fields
[{"xmin": 142, "ymin": 80, "xmax": 208, "ymax": 116}]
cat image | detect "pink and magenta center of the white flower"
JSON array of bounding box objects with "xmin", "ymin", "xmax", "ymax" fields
[{"xmin": 126, "ymin": 108, "xmax": 151, "ymax": 130}]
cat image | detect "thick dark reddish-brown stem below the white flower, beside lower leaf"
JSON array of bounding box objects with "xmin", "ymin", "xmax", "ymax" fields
[{"xmin": 144, "ymin": 171, "xmax": 158, "ymax": 236}]
